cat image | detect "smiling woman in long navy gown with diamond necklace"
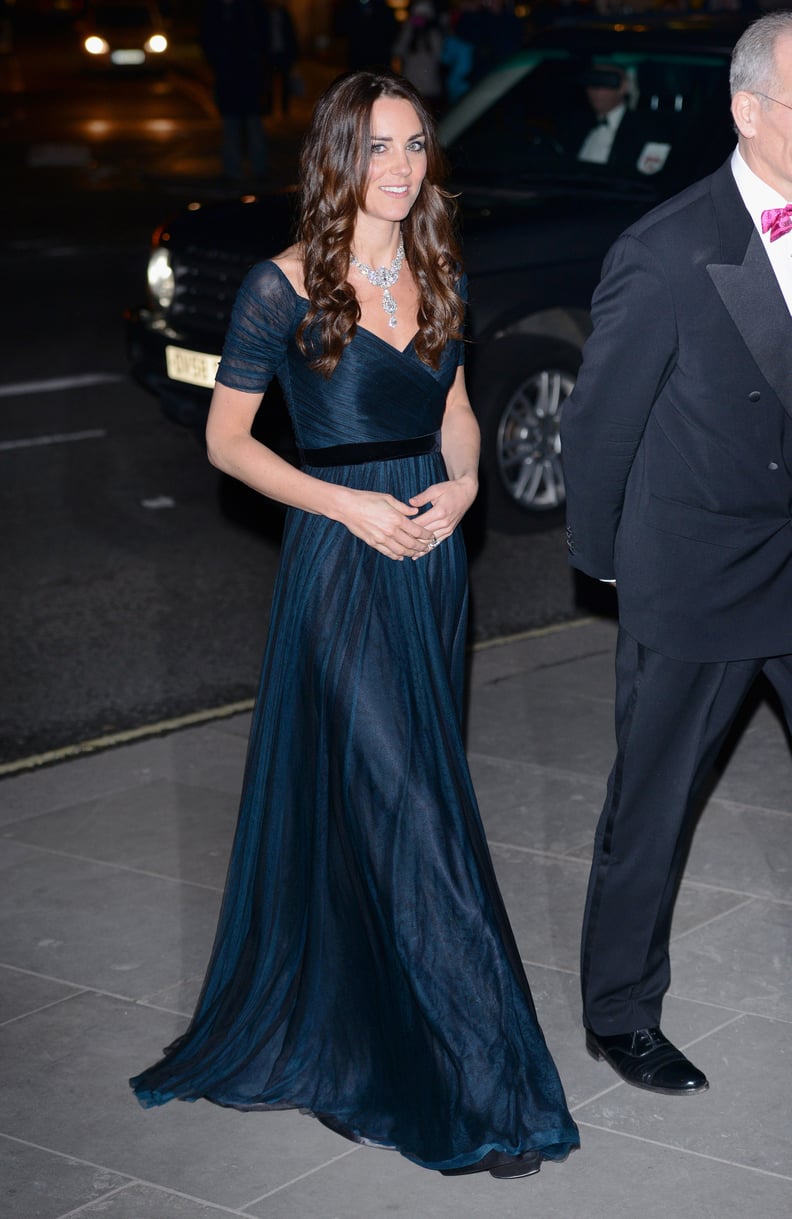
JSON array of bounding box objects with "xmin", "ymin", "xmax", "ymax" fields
[{"xmin": 132, "ymin": 72, "xmax": 578, "ymax": 1176}]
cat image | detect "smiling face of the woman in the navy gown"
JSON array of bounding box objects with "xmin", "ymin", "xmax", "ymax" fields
[{"xmin": 363, "ymin": 98, "xmax": 426, "ymax": 222}]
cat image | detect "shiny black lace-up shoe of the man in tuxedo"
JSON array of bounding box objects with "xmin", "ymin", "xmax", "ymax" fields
[{"xmin": 586, "ymin": 1028, "xmax": 709, "ymax": 1096}]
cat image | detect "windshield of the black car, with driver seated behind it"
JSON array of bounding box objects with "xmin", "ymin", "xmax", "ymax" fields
[{"xmin": 440, "ymin": 49, "xmax": 734, "ymax": 194}]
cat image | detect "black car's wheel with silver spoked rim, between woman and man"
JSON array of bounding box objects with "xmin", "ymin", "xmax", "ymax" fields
[{"xmin": 473, "ymin": 338, "xmax": 580, "ymax": 533}]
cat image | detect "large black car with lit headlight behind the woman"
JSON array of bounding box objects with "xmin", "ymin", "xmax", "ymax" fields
[{"xmin": 128, "ymin": 16, "xmax": 744, "ymax": 531}]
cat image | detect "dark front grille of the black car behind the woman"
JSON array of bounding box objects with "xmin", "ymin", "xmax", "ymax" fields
[{"xmin": 167, "ymin": 245, "xmax": 261, "ymax": 339}]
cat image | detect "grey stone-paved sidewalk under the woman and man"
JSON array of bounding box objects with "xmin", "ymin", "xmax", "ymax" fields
[{"xmin": 0, "ymin": 620, "xmax": 792, "ymax": 1219}]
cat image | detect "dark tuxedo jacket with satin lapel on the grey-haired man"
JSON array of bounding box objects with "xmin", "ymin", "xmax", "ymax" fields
[{"xmin": 562, "ymin": 162, "xmax": 792, "ymax": 661}]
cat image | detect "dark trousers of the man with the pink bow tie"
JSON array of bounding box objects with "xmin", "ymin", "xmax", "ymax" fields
[{"xmin": 580, "ymin": 630, "xmax": 792, "ymax": 1036}]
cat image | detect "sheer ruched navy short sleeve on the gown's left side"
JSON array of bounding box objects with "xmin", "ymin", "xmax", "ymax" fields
[{"xmin": 217, "ymin": 262, "xmax": 297, "ymax": 394}]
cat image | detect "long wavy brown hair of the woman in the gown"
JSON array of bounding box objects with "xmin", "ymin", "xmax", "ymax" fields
[{"xmin": 297, "ymin": 71, "xmax": 464, "ymax": 377}]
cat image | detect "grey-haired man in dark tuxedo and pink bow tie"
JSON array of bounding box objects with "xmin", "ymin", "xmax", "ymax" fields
[{"xmin": 562, "ymin": 11, "xmax": 792, "ymax": 1095}]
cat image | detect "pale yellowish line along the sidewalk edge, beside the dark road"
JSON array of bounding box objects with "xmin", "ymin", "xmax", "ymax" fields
[{"xmin": 0, "ymin": 618, "xmax": 595, "ymax": 779}]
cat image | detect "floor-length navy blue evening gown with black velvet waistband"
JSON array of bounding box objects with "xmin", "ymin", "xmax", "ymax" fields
[{"xmin": 132, "ymin": 262, "xmax": 579, "ymax": 1169}]
